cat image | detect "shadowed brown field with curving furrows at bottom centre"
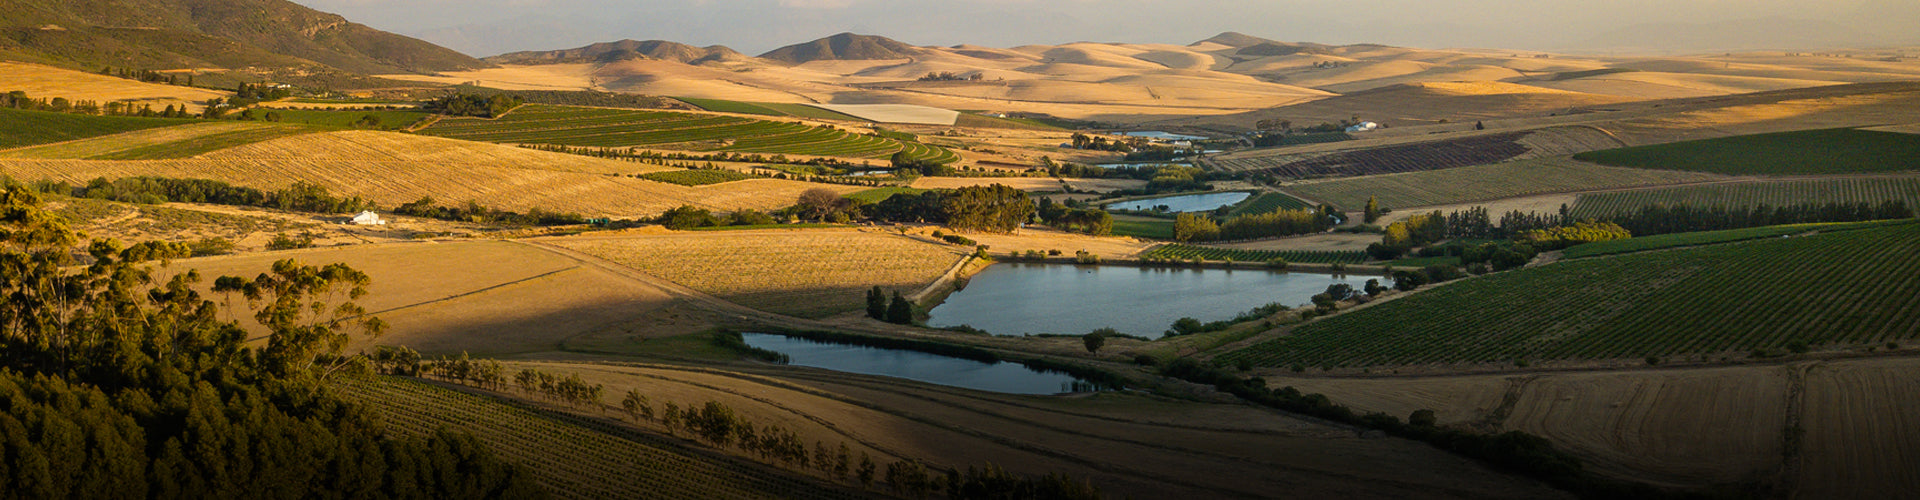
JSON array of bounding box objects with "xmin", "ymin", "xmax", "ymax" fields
[{"xmin": 507, "ymin": 362, "xmax": 1565, "ymax": 498}]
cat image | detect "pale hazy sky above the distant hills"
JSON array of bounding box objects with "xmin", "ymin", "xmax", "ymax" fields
[{"xmin": 294, "ymin": 0, "xmax": 1920, "ymax": 56}]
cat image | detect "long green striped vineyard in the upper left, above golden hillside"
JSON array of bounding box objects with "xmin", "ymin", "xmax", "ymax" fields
[{"xmin": 420, "ymin": 104, "xmax": 958, "ymax": 162}]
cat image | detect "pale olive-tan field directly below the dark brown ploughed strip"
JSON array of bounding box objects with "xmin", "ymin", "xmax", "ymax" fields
[{"xmin": 1286, "ymin": 158, "xmax": 1724, "ymax": 210}]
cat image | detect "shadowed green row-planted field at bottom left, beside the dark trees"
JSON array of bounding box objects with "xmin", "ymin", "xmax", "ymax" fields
[{"xmin": 334, "ymin": 377, "xmax": 854, "ymax": 498}]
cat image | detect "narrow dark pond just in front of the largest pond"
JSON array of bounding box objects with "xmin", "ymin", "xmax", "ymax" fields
[{"xmin": 741, "ymin": 333, "xmax": 1087, "ymax": 394}]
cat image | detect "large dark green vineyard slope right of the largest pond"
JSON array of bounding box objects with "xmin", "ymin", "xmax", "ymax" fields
[{"xmin": 1219, "ymin": 223, "xmax": 1920, "ymax": 367}]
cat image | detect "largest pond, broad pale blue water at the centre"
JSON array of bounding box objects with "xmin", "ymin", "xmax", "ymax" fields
[{"xmin": 927, "ymin": 263, "xmax": 1392, "ymax": 338}]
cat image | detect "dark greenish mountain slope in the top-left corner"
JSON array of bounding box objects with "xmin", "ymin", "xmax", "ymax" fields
[{"xmin": 0, "ymin": 0, "xmax": 492, "ymax": 75}]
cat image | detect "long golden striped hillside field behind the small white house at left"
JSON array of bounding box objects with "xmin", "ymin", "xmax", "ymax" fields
[{"xmin": 0, "ymin": 131, "xmax": 860, "ymax": 217}]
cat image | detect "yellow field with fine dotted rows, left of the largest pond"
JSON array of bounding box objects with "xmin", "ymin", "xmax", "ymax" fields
[{"xmin": 538, "ymin": 229, "xmax": 972, "ymax": 317}]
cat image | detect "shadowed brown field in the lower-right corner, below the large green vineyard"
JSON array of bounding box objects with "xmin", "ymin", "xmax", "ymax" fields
[{"xmin": 1267, "ymin": 358, "xmax": 1920, "ymax": 498}]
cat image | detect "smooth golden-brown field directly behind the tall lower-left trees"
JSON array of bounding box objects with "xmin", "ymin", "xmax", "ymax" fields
[{"xmin": 171, "ymin": 240, "xmax": 672, "ymax": 356}]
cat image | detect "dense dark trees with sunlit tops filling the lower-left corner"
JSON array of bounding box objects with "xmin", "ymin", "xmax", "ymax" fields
[{"xmin": 0, "ymin": 181, "xmax": 543, "ymax": 498}]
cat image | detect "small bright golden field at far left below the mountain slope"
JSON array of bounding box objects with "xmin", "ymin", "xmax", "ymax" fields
[{"xmin": 0, "ymin": 62, "xmax": 228, "ymax": 112}]
